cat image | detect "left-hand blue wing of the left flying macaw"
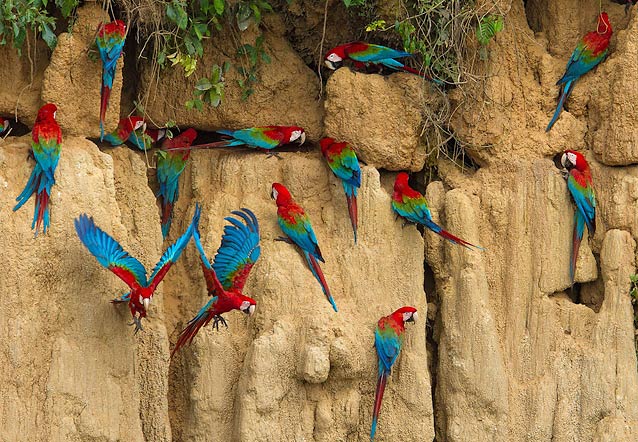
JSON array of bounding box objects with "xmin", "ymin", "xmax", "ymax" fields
[{"xmin": 74, "ymin": 214, "xmax": 147, "ymax": 289}]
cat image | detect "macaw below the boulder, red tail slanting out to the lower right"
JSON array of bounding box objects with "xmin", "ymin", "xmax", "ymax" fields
[{"xmin": 392, "ymin": 172, "xmax": 483, "ymax": 250}]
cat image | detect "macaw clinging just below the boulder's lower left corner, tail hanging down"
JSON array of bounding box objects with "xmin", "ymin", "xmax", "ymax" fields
[{"xmin": 319, "ymin": 137, "xmax": 361, "ymax": 243}]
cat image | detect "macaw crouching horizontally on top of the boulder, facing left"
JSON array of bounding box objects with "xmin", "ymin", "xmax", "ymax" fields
[{"xmin": 324, "ymin": 41, "xmax": 440, "ymax": 83}]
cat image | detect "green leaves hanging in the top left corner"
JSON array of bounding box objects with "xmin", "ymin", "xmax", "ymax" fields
[{"xmin": 0, "ymin": 0, "xmax": 80, "ymax": 52}]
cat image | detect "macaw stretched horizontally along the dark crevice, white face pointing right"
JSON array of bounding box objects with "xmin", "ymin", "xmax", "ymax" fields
[{"xmin": 193, "ymin": 126, "xmax": 306, "ymax": 155}]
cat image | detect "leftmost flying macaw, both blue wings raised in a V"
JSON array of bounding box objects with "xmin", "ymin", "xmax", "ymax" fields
[{"xmin": 75, "ymin": 205, "xmax": 201, "ymax": 333}]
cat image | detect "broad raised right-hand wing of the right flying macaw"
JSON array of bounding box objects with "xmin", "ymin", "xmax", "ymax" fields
[{"xmin": 213, "ymin": 208, "xmax": 261, "ymax": 291}]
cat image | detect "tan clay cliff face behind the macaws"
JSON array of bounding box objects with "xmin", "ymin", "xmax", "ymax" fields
[{"xmin": 0, "ymin": 0, "xmax": 638, "ymax": 442}]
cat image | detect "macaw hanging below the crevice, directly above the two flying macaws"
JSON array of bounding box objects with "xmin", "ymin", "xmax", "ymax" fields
[{"xmin": 157, "ymin": 128, "xmax": 197, "ymax": 238}]
